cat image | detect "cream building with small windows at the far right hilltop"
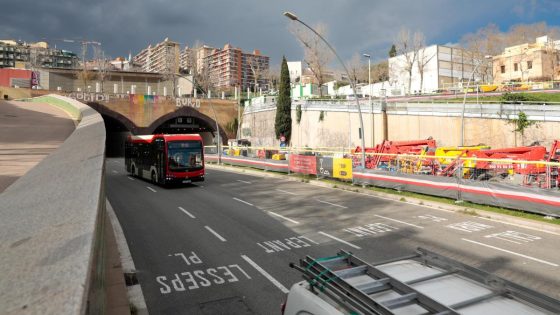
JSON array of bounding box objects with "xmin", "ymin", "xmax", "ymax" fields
[{"xmin": 493, "ymin": 36, "xmax": 560, "ymax": 84}]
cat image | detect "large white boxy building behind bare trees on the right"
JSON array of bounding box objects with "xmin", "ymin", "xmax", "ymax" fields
[{"xmin": 387, "ymin": 45, "xmax": 492, "ymax": 95}]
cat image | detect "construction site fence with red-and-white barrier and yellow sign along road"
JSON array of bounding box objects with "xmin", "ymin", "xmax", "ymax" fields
[{"xmin": 205, "ymin": 146, "xmax": 560, "ymax": 217}]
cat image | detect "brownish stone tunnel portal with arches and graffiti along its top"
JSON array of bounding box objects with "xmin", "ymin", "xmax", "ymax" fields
[{"xmin": 73, "ymin": 93, "xmax": 239, "ymax": 156}]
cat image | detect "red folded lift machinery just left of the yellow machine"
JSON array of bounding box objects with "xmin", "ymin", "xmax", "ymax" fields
[{"xmin": 353, "ymin": 139, "xmax": 436, "ymax": 168}]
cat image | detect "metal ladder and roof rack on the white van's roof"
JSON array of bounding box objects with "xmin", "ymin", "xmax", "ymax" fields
[{"xmin": 290, "ymin": 248, "xmax": 560, "ymax": 315}]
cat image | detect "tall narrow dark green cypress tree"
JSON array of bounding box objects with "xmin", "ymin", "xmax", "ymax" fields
[{"xmin": 274, "ymin": 57, "xmax": 292, "ymax": 143}]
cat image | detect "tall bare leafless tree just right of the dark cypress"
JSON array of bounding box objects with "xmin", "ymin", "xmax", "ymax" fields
[{"xmin": 290, "ymin": 23, "xmax": 332, "ymax": 97}]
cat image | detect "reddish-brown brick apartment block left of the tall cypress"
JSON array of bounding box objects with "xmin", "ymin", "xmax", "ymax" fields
[{"xmin": 203, "ymin": 44, "xmax": 270, "ymax": 90}]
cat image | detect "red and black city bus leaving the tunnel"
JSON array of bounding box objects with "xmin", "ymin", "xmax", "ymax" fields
[{"xmin": 124, "ymin": 134, "xmax": 204, "ymax": 185}]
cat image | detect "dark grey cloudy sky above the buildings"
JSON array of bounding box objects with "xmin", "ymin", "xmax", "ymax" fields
[{"xmin": 0, "ymin": 0, "xmax": 560, "ymax": 65}]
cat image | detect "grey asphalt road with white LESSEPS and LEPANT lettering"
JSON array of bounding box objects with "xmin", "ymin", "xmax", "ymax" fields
[{"xmin": 106, "ymin": 159, "xmax": 560, "ymax": 314}]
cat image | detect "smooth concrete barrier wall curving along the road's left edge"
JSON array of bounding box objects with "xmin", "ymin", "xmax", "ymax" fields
[{"xmin": 0, "ymin": 96, "xmax": 105, "ymax": 314}]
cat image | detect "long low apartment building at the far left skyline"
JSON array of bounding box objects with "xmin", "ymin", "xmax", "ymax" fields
[{"xmin": 0, "ymin": 40, "xmax": 79, "ymax": 69}]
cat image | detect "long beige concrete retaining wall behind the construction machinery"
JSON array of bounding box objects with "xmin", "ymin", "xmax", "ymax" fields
[{"xmin": 241, "ymin": 102, "xmax": 560, "ymax": 148}]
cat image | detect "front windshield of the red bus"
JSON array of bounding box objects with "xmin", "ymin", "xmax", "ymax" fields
[{"xmin": 167, "ymin": 141, "xmax": 202, "ymax": 172}]
